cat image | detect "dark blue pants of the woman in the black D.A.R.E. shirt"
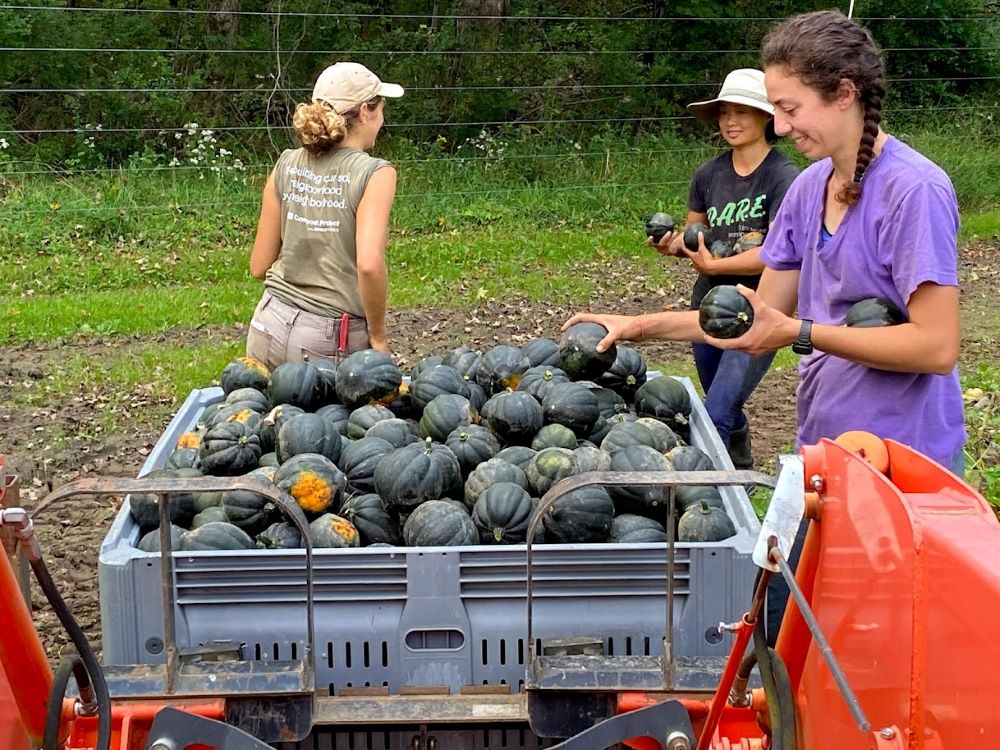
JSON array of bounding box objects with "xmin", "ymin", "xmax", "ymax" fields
[{"xmin": 691, "ymin": 344, "xmax": 774, "ymax": 445}]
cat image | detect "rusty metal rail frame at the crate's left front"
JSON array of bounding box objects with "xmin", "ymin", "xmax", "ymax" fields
[{"xmin": 32, "ymin": 476, "xmax": 315, "ymax": 696}]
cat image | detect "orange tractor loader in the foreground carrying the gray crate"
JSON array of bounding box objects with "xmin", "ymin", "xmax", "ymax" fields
[{"xmin": 0, "ymin": 436, "xmax": 1000, "ymax": 750}]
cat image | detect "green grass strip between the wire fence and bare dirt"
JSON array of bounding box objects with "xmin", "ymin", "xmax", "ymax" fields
[{"xmin": 0, "ymin": 124, "xmax": 1000, "ymax": 506}]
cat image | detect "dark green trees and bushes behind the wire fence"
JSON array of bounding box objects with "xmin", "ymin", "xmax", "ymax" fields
[{"xmin": 0, "ymin": 0, "xmax": 1000, "ymax": 169}]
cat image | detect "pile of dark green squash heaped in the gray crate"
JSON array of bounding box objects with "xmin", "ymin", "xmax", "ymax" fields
[{"xmin": 137, "ymin": 323, "xmax": 736, "ymax": 551}]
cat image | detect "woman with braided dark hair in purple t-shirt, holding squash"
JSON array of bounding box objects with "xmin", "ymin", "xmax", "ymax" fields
[{"xmin": 568, "ymin": 11, "xmax": 966, "ymax": 474}]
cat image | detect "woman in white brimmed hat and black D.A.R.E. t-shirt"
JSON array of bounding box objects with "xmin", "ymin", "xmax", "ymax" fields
[{"xmin": 647, "ymin": 68, "xmax": 798, "ymax": 469}]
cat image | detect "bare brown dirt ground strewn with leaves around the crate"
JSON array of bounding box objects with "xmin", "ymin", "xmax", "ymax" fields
[{"xmin": 0, "ymin": 244, "xmax": 1000, "ymax": 655}]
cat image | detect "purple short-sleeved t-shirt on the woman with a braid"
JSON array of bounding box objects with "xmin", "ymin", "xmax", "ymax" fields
[{"xmin": 761, "ymin": 138, "xmax": 966, "ymax": 467}]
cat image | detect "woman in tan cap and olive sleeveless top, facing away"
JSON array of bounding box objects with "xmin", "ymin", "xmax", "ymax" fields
[{"xmin": 247, "ymin": 62, "xmax": 403, "ymax": 368}]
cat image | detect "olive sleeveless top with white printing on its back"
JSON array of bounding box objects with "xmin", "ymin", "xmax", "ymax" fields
[{"xmin": 264, "ymin": 148, "xmax": 389, "ymax": 318}]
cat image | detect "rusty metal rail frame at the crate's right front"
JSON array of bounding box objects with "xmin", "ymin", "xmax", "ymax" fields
[{"xmin": 525, "ymin": 471, "xmax": 775, "ymax": 690}]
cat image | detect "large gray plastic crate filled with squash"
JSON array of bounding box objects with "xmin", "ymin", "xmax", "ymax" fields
[{"xmin": 99, "ymin": 378, "xmax": 760, "ymax": 694}]
